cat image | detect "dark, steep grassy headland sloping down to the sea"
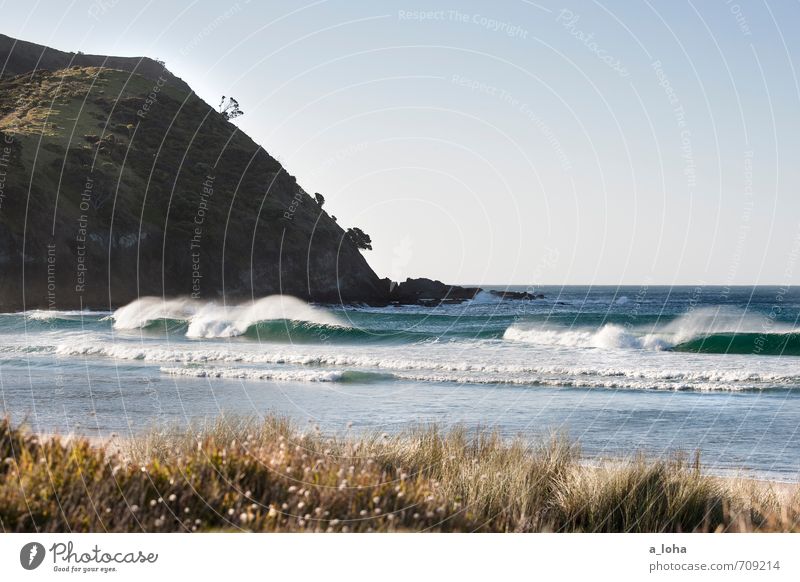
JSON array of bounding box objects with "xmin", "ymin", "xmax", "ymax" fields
[{"xmin": 0, "ymin": 37, "xmax": 389, "ymax": 311}]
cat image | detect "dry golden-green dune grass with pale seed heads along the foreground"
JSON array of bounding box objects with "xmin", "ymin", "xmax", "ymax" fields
[{"xmin": 0, "ymin": 418, "xmax": 800, "ymax": 532}]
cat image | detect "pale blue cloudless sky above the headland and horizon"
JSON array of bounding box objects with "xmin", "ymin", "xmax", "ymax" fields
[{"xmin": 0, "ymin": 0, "xmax": 800, "ymax": 284}]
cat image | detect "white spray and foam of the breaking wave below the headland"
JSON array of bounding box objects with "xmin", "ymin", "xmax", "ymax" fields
[{"xmin": 112, "ymin": 295, "xmax": 347, "ymax": 338}]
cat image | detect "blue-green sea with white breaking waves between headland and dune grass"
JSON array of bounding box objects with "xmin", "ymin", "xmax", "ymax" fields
[{"xmin": 0, "ymin": 286, "xmax": 800, "ymax": 481}]
